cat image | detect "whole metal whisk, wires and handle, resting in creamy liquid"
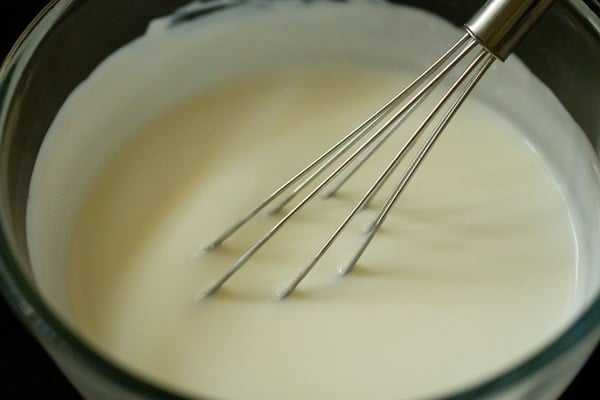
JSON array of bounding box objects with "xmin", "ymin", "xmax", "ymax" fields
[{"xmin": 201, "ymin": 0, "xmax": 552, "ymax": 299}]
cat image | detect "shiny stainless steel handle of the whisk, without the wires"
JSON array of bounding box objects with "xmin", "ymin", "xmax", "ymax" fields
[{"xmin": 465, "ymin": 0, "xmax": 554, "ymax": 60}]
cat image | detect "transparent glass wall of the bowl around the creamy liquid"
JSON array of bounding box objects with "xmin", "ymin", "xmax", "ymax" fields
[{"xmin": 0, "ymin": 0, "xmax": 600, "ymax": 400}]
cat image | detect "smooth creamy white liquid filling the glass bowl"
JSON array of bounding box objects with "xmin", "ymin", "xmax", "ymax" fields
[{"xmin": 23, "ymin": 0, "xmax": 591, "ymax": 399}]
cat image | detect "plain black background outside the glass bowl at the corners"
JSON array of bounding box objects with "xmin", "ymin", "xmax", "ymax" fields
[{"xmin": 0, "ymin": 0, "xmax": 600, "ymax": 400}]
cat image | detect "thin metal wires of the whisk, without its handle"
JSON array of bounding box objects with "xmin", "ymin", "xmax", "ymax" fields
[{"xmin": 200, "ymin": 34, "xmax": 495, "ymax": 299}]
